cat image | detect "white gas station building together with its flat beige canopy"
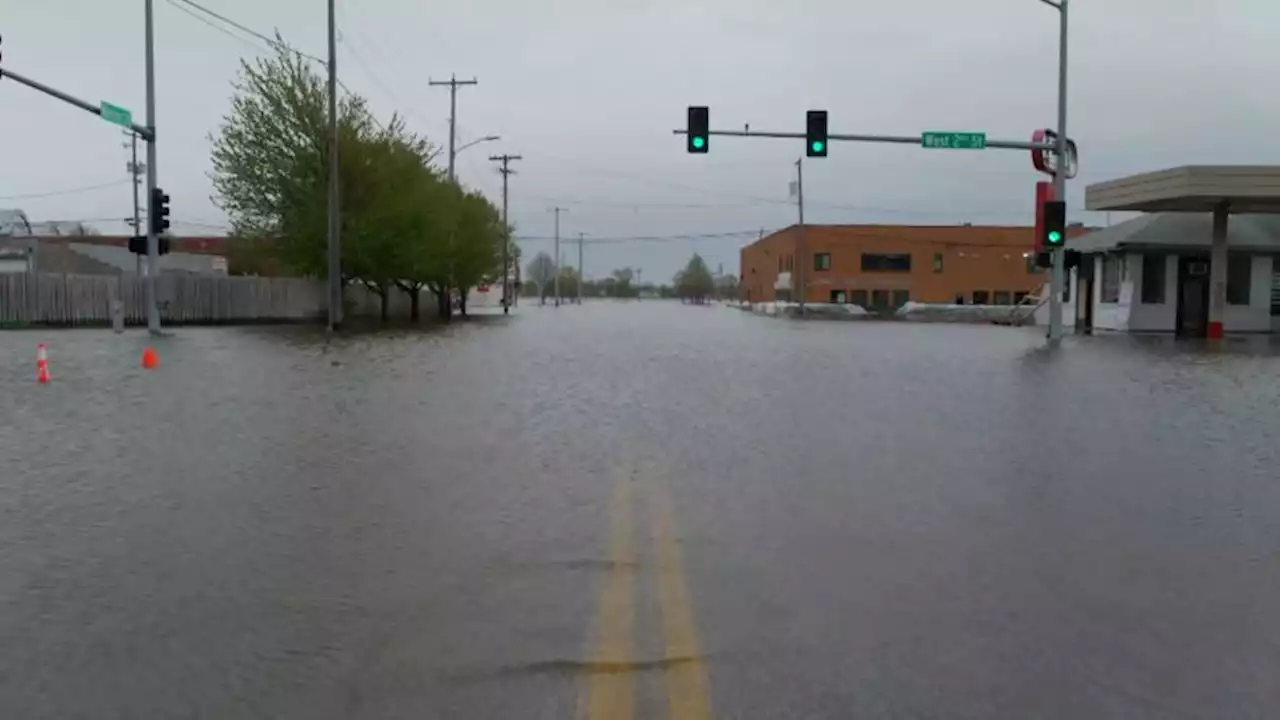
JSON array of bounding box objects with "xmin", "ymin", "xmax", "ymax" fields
[{"xmin": 1068, "ymin": 165, "xmax": 1280, "ymax": 338}]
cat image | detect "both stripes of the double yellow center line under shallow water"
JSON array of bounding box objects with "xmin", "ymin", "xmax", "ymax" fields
[{"xmin": 582, "ymin": 458, "xmax": 710, "ymax": 720}]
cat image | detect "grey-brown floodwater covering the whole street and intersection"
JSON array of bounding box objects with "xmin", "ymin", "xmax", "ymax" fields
[{"xmin": 0, "ymin": 302, "xmax": 1280, "ymax": 720}]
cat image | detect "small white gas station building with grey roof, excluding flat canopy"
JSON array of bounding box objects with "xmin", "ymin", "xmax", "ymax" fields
[{"xmin": 1068, "ymin": 213, "xmax": 1280, "ymax": 337}]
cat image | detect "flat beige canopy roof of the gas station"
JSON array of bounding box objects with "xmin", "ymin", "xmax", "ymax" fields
[{"xmin": 1084, "ymin": 165, "xmax": 1280, "ymax": 213}]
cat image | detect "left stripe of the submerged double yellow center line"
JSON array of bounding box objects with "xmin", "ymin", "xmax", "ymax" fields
[{"xmin": 585, "ymin": 468, "xmax": 636, "ymax": 720}]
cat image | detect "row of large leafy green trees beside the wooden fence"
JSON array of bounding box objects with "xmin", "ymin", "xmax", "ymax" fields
[{"xmin": 210, "ymin": 37, "xmax": 520, "ymax": 320}]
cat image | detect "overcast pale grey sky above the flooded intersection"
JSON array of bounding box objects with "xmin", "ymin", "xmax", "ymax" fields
[{"xmin": 0, "ymin": 0, "xmax": 1280, "ymax": 279}]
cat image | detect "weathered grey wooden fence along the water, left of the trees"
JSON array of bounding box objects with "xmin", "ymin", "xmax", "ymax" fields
[{"xmin": 0, "ymin": 273, "xmax": 328, "ymax": 327}]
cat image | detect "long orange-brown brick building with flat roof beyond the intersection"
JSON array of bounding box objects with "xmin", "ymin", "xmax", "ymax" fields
[{"xmin": 740, "ymin": 225, "xmax": 1087, "ymax": 309}]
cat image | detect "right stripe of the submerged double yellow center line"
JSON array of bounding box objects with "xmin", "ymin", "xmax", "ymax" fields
[{"xmin": 648, "ymin": 471, "xmax": 712, "ymax": 720}]
